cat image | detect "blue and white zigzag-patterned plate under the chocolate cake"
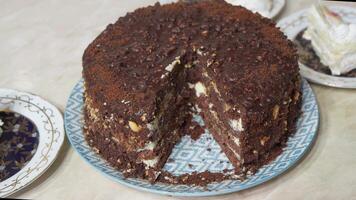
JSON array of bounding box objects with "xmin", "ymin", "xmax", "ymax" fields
[{"xmin": 64, "ymin": 80, "xmax": 319, "ymax": 196}]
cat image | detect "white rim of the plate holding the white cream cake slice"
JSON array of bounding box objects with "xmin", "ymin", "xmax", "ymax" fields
[{"xmin": 277, "ymin": 6, "xmax": 356, "ymax": 88}]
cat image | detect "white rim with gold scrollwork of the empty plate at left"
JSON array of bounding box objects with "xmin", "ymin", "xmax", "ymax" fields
[{"xmin": 0, "ymin": 89, "xmax": 65, "ymax": 198}]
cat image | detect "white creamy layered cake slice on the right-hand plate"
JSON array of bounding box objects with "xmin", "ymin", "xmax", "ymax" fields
[{"xmin": 303, "ymin": 4, "xmax": 356, "ymax": 75}]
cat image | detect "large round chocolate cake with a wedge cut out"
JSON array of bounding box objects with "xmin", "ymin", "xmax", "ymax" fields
[{"xmin": 83, "ymin": 0, "xmax": 301, "ymax": 182}]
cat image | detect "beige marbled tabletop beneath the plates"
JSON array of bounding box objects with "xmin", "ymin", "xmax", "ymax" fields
[{"xmin": 0, "ymin": 0, "xmax": 356, "ymax": 200}]
